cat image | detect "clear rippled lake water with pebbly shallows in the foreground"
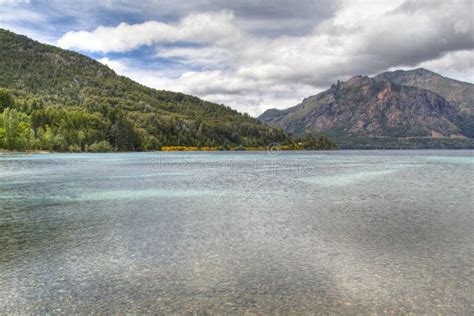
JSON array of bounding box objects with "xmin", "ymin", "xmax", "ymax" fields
[{"xmin": 0, "ymin": 151, "xmax": 474, "ymax": 314}]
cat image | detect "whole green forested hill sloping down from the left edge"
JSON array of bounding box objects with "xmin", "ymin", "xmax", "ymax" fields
[{"xmin": 0, "ymin": 29, "xmax": 290, "ymax": 151}]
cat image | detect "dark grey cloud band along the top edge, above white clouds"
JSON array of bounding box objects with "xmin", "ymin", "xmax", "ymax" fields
[{"xmin": 0, "ymin": 0, "xmax": 339, "ymax": 37}]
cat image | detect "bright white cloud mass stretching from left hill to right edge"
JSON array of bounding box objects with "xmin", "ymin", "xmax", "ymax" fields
[{"xmin": 58, "ymin": 0, "xmax": 474, "ymax": 115}]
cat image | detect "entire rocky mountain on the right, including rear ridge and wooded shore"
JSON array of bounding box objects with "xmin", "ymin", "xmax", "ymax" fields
[{"xmin": 259, "ymin": 68, "xmax": 474, "ymax": 148}]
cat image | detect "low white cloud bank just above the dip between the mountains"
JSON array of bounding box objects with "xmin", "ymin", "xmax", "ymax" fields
[{"xmin": 94, "ymin": 58, "xmax": 318, "ymax": 116}]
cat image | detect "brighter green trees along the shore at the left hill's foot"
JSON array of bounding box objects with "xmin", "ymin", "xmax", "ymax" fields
[{"xmin": 0, "ymin": 90, "xmax": 335, "ymax": 152}]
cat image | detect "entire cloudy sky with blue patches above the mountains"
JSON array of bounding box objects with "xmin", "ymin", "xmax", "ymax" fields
[{"xmin": 0, "ymin": 0, "xmax": 474, "ymax": 115}]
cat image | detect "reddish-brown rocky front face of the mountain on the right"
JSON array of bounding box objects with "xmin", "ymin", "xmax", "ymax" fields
[{"xmin": 260, "ymin": 76, "xmax": 469, "ymax": 139}]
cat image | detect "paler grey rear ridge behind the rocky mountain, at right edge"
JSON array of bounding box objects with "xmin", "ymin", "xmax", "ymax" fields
[{"xmin": 375, "ymin": 68, "xmax": 474, "ymax": 114}]
